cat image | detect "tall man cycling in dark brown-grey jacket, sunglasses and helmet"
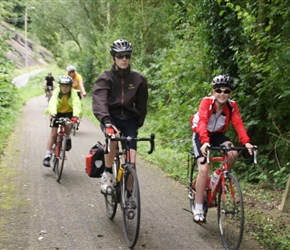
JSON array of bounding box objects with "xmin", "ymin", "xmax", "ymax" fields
[{"xmin": 93, "ymin": 39, "xmax": 148, "ymax": 193}]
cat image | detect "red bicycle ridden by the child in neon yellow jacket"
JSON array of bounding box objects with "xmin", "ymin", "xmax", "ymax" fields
[{"xmin": 50, "ymin": 117, "xmax": 71, "ymax": 182}]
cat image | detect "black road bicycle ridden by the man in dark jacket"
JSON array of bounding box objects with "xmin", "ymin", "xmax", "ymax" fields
[{"xmin": 104, "ymin": 134, "xmax": 155, "ymax": 248}]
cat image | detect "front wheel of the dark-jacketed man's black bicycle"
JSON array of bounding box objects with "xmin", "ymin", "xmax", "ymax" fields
[{"xmin": 121, "ymin": 166, "xmax": 141, "ymax": 248}]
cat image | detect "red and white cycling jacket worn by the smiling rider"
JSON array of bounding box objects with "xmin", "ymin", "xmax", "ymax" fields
[{"xmin": 190, "ymin": 96, "xmax": 250, "ymax": 145}]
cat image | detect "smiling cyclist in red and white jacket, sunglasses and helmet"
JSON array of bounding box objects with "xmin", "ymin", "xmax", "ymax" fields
[{"xmin": 190, "ymin": 75, "xmax": 253, "ymax": 224}]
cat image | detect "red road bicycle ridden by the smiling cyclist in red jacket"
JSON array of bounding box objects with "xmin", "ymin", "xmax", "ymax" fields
[{"xmin": 188, "ymin": 145, "xmax": 257, "ymax": 250}]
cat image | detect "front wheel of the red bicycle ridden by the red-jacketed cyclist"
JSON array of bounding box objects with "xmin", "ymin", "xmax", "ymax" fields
[{"xmin": 218, "ymin": 172, "xmax": 244, "ymax": 250}]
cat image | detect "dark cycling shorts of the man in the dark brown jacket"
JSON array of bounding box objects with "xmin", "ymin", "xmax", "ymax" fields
[{"xmin": 101, "ymin": 117, "xmax": 138, "ymax": 150}]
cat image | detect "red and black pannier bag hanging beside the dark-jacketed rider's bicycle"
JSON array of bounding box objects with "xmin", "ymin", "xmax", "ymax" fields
[{"xmin": 86, "ymin": 142, "xmax": 105, "ymax": 178}]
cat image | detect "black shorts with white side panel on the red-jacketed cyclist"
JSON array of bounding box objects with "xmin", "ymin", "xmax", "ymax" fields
[{"xmin": 192, "ymin": 133, "xmax": 230, "ymax": 158}]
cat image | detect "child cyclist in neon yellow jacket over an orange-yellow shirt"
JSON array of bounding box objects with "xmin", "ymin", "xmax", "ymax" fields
[{"xmin": 43, "ymin": 76, "xmax": 82, "ymax": 167}]
